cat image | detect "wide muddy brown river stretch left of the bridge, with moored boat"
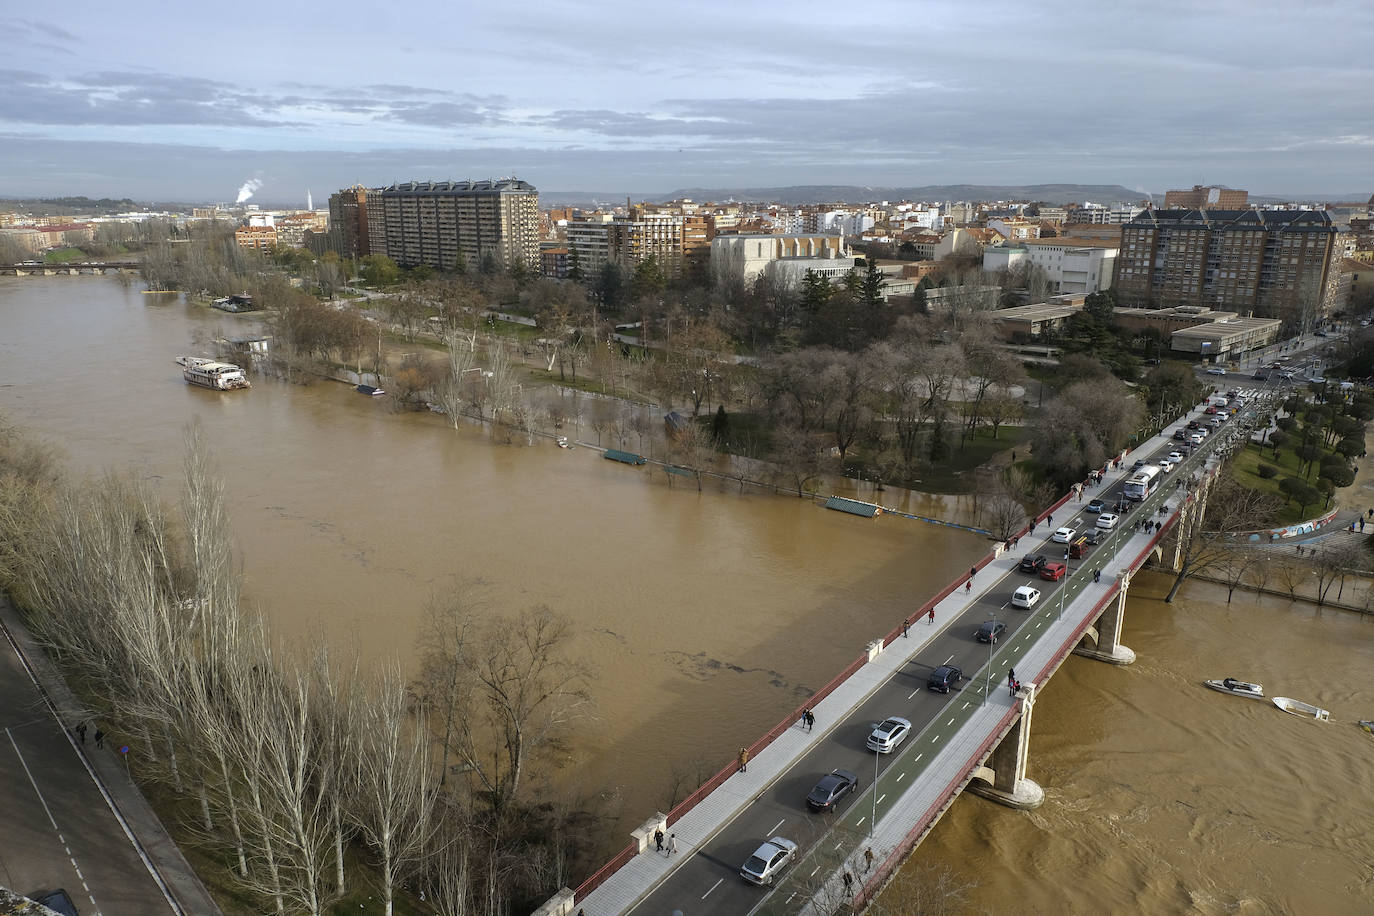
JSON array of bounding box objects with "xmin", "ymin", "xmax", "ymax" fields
[{"xmin": 0, "ymin": 277, "xmax": 987, "ymax": 829}]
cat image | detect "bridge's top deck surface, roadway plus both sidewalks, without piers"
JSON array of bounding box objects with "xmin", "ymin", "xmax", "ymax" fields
[{"xmin": 572, "ymin": 390, "xmax": 1264, "ymax": 916}]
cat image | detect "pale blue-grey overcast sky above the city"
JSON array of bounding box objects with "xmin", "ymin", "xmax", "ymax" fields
[{"xmin": 0, "ymin": 0, "xmax": 1374, "ymax": 205}]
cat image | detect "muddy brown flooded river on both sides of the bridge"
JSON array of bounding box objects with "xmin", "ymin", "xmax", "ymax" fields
[{"xmin": 0, "ymin": 277, "xmax": 1374, "ymax": 913}]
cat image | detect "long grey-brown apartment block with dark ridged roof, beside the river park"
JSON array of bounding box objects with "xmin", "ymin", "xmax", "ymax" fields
[{"xmin": 368, "ymin": 179, "xmax": 539, "ymax": 271}]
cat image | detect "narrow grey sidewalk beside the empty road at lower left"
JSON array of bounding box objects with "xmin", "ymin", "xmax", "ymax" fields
[{"xmin": 0, "ymin": 595, "xmax": 220, "ymax": 916}]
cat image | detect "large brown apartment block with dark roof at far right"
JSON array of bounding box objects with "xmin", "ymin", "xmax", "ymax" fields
[{"xmin": 1114, "ymin": 210, "xmax": 1336, "ymax": 325}]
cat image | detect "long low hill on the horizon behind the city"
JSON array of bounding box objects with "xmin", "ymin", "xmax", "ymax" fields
[{"xmin": 650, "ymin": 184, "xmax": 1162, "ymax": 205}]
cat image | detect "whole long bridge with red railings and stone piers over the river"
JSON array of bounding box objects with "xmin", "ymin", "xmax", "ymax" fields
[{"xmin": 537, "ymin": 389, "xmax": 1276, "ymax": 916}]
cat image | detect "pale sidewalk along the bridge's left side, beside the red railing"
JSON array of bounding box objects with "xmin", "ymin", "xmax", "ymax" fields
[{"xmin": 573, "ymin": 455, "xmax": 1167, "ymax": 916}]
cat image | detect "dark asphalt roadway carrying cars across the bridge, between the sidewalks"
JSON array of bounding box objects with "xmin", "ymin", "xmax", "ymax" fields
[{"xmin": 629, "ymin": 383, "xmax": 1280, "ymax": 916}]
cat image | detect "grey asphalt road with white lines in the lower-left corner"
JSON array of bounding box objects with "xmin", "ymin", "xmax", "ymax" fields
[{"xmin": 0, "ymin": 609, "xmax": 199, "ymax": 916}]
